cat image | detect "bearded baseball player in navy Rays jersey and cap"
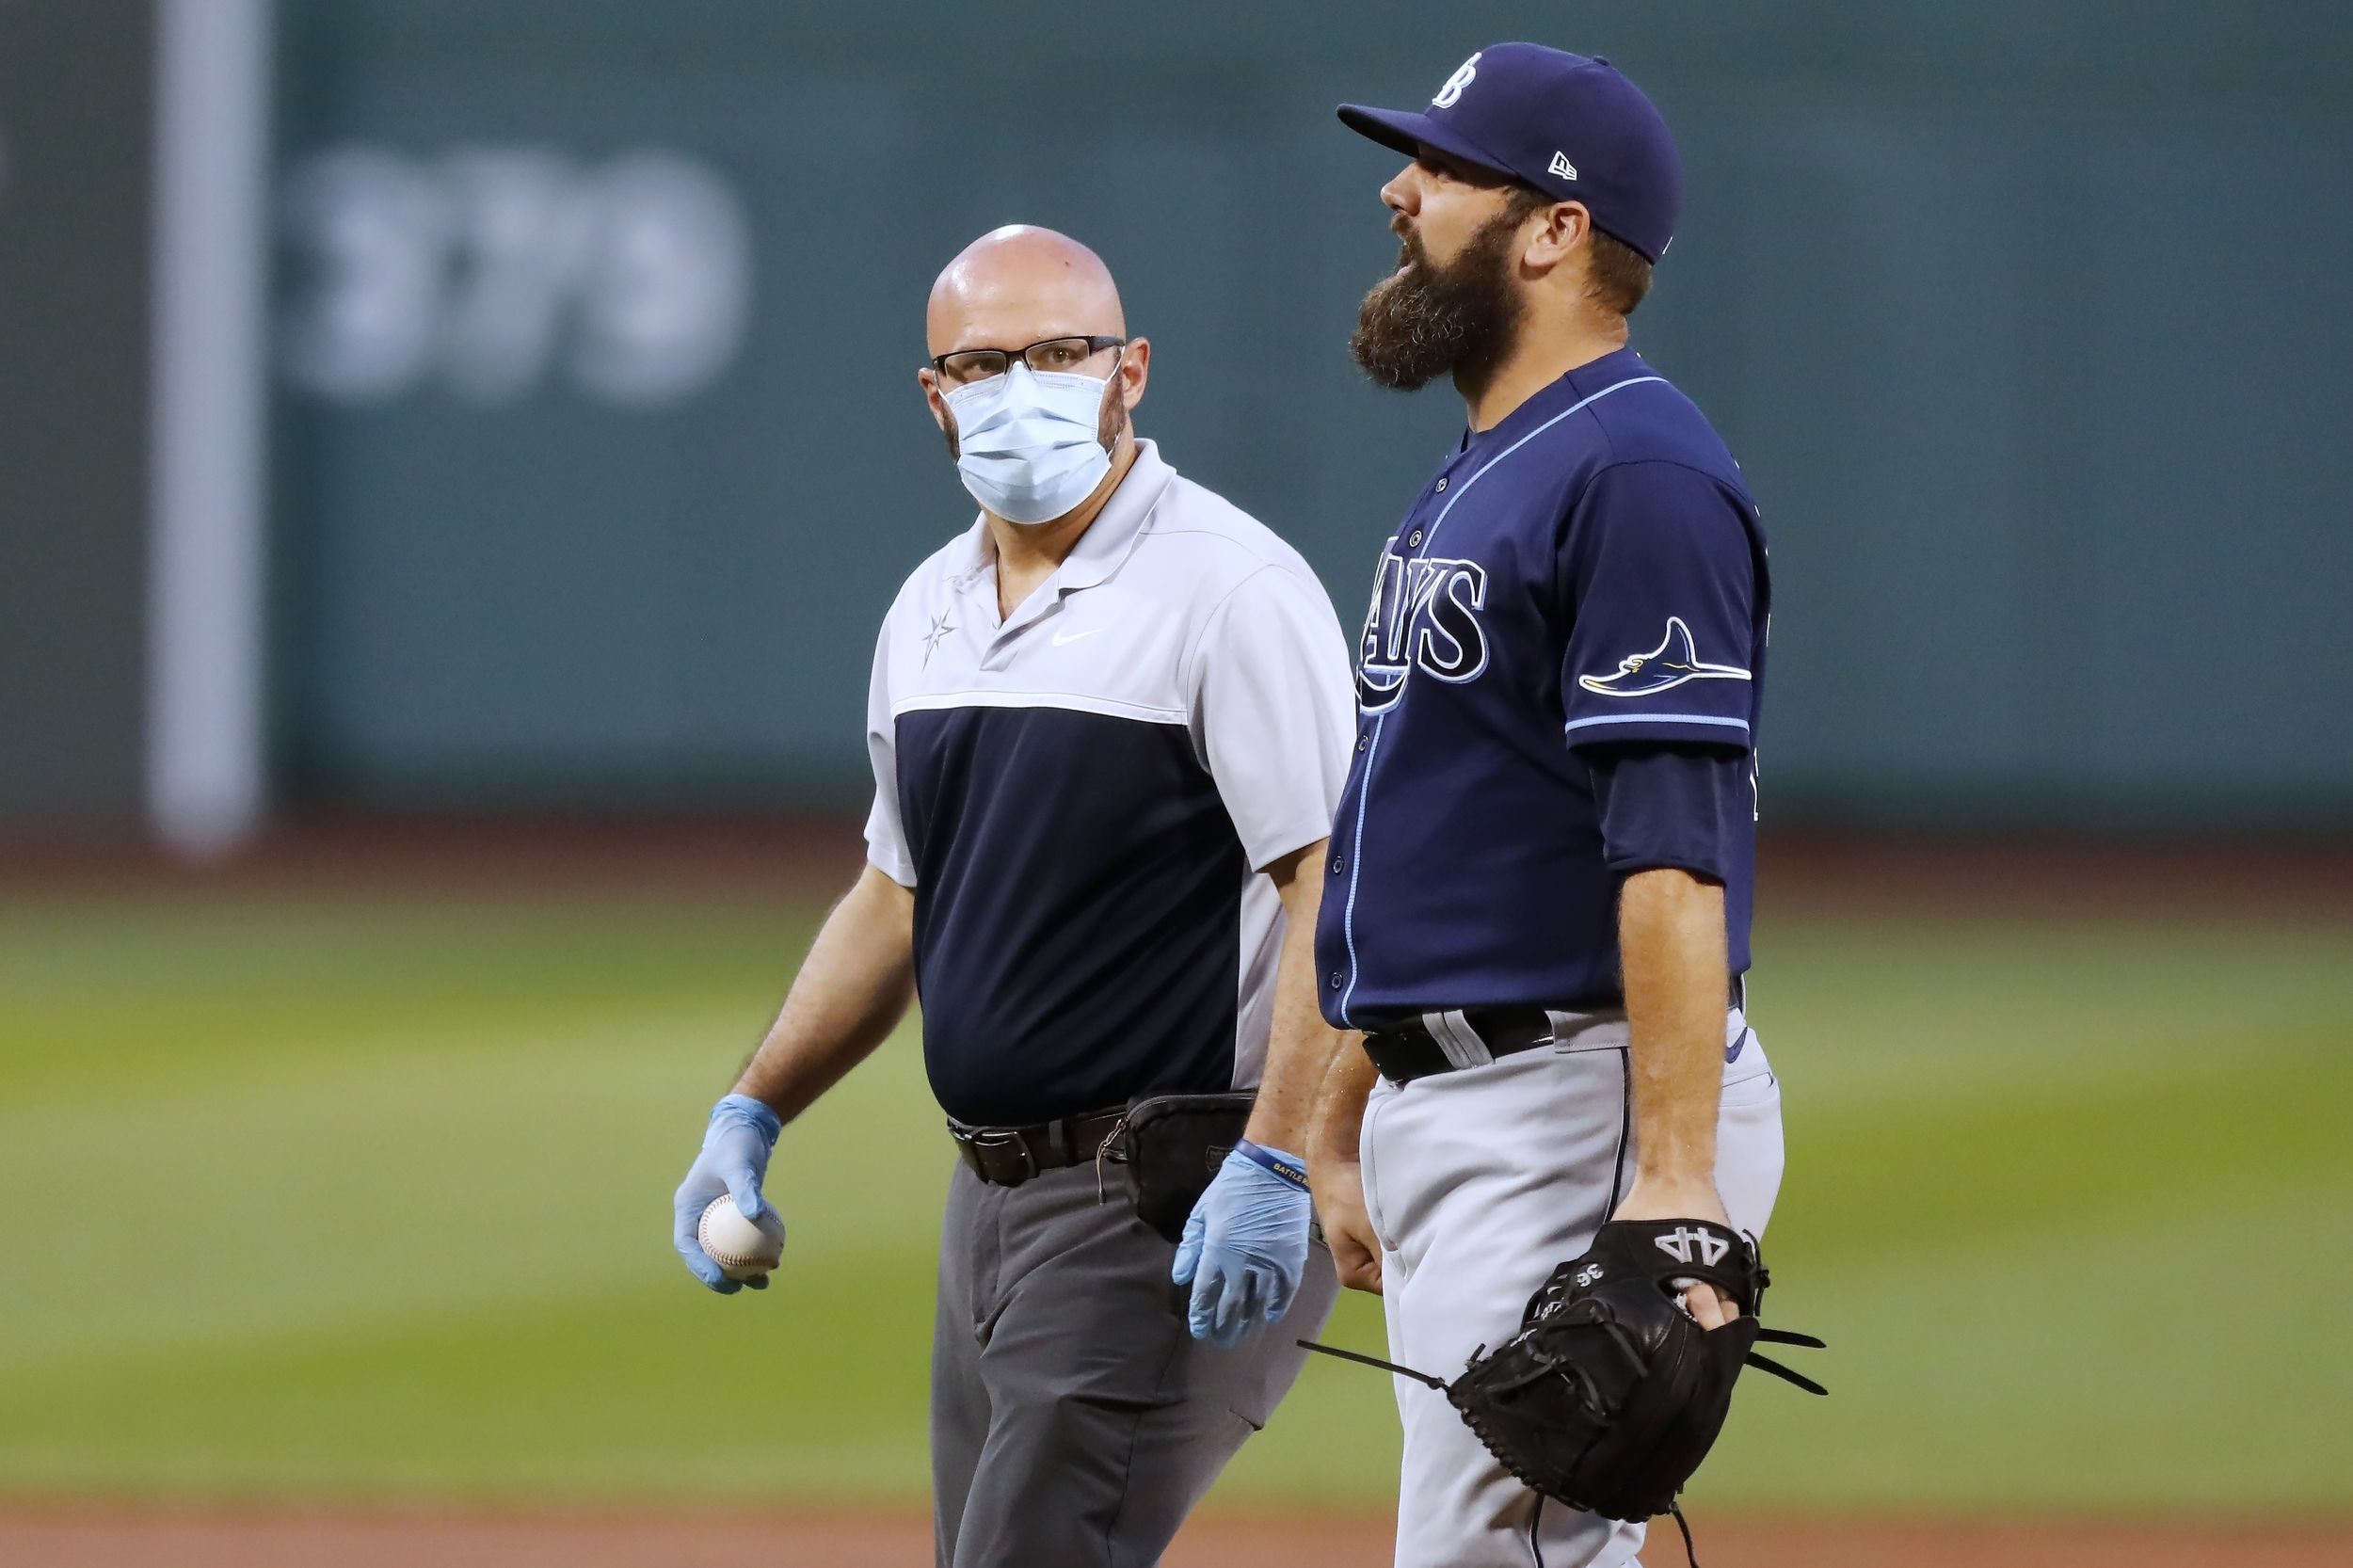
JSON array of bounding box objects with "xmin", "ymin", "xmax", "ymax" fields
[{"xmin": 1308, "ymin": 42, "xmax": 1782, "ymax": 1568}]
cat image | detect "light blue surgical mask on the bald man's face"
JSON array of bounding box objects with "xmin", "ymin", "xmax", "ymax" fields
[{"xmin": 944, "ymin": 362, "xmax": 1111, "ymax": 522}]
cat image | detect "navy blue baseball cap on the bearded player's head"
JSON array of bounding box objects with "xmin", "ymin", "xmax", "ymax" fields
[{"xmin": 1339, "ymin": 45, "xmax": 1683, "ymax": 262}]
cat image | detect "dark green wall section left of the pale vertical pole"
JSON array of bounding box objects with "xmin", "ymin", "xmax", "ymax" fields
[{"xmin": 0, "ymin": 0, "xmax": 153, "ymax": 831}]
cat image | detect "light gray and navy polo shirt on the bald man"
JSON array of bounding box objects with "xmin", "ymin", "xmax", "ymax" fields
[{"xmin": 866, "ymin": 440, "xmax": 1353, "ymax": 1126}]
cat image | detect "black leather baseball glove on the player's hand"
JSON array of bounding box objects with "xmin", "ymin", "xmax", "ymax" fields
[{"xmin": 1313, "ymin": 1220, "xmax": 1826, "ymax": 1553}]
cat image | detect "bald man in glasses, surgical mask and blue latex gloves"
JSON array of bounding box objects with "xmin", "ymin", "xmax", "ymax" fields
[{"xmin": 676, "ymin": 229, "xmax": 1353, "ymax": 1568}]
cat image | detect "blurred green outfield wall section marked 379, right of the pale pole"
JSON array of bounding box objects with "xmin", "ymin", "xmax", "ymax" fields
[{"xmin": 18, "ymin": 0, "xmax": 2353, "ymax": 831}]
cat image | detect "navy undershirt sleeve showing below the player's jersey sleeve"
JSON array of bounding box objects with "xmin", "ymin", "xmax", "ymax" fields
[{"xmin": 1586, "ymin": 742, "xmax": 1755, "ymax": 883}]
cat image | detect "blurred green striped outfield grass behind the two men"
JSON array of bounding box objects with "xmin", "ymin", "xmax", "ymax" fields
[{"xmin": 0, "ymin": 892, "xmax": 2353, "ymax": 1509}]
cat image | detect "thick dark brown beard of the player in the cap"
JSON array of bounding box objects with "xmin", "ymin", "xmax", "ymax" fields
[{"xmin": 1349, "ymin": 212, "xmax": 1525, "ymax": 391}]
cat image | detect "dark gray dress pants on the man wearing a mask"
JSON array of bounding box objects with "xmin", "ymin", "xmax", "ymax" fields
[{"xmin": 932, "ymin": 1165, "xmax": 1339, "ymax": 1568}]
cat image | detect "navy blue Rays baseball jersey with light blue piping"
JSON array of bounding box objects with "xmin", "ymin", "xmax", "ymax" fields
[{"xmin": 1316, "ymin": 348, "xmax": 1769, "ymax": 1029}]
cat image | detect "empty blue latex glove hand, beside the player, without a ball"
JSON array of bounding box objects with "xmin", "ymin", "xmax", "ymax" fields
[{"xmin": 1170, "ymin": 1140, "xmax": 1316, "ymax": 1349}]
